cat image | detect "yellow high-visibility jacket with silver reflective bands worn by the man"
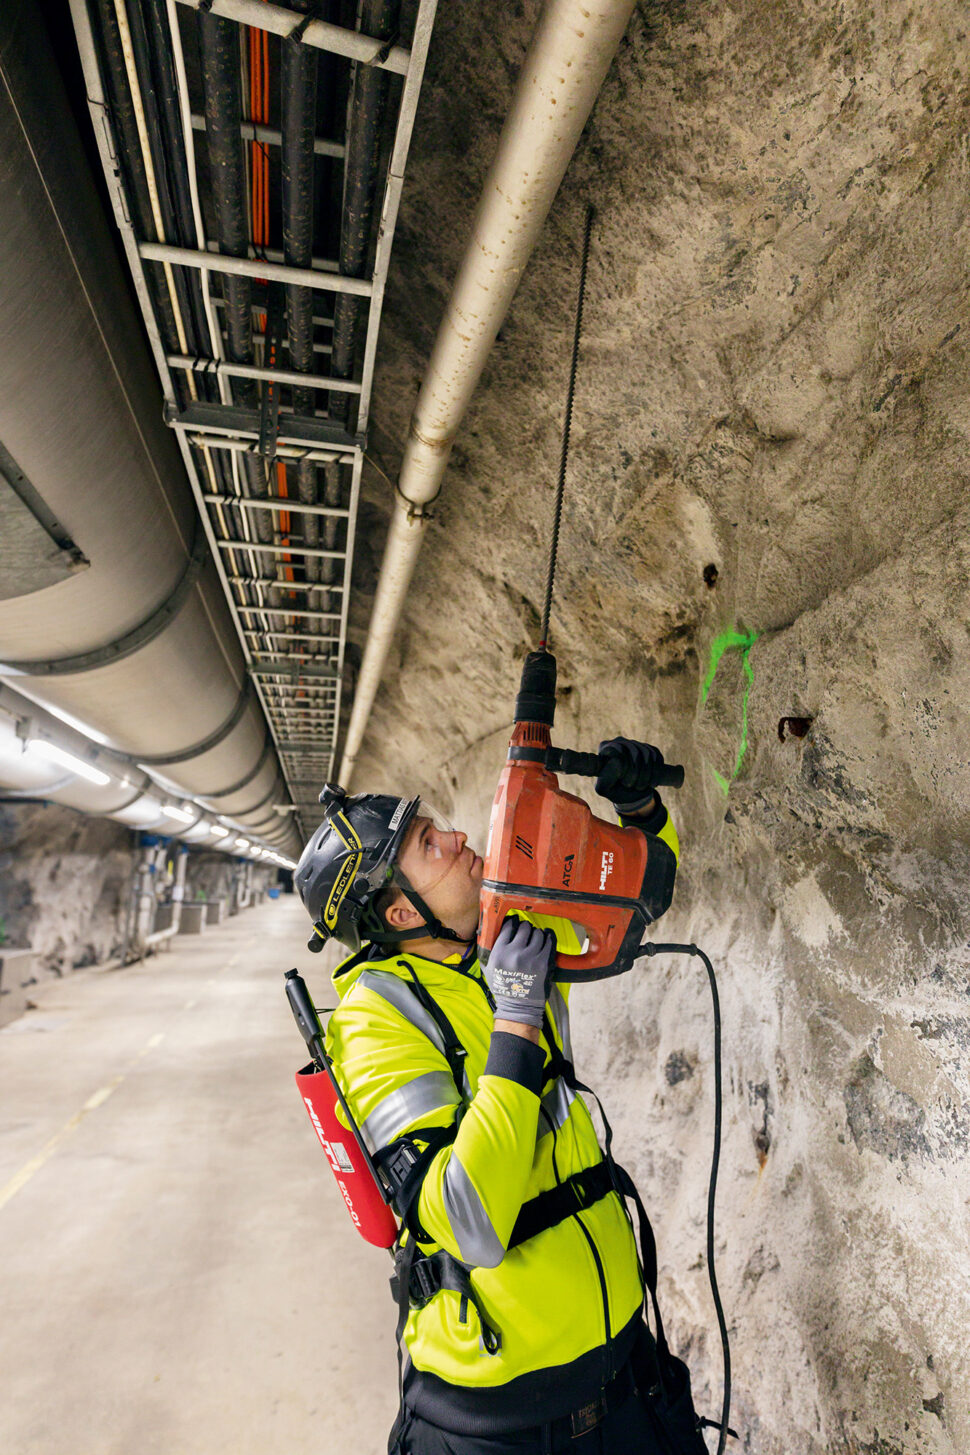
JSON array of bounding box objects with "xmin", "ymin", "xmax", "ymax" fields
[{"xmin": 327, "ymin": 818, "xmax": 679, "ymax": 1433}]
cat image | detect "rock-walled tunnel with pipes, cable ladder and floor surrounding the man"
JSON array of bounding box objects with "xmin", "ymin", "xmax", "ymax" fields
[{"xmin": 0, "ymin": 0, "xmax": 970, "ymax": 1455}]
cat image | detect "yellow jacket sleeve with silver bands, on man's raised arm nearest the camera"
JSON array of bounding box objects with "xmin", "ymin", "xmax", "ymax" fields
[{"xmin": 327, "ymin": 978, "xmax": 544, "ymax": 1267}]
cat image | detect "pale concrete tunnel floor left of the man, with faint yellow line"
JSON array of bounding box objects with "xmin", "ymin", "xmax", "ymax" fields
[{"xmin": 0, "ymin": 898, "xmax": 397, "ymax": 1455}]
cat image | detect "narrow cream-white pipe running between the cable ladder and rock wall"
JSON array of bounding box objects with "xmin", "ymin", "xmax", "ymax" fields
[{"xmin": 340, "ymin": 0, "xmax": 634, "ymax": 786}]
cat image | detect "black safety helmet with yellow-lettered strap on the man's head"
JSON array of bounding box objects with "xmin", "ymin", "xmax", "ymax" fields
[{"xmin": 294, "ymin": 783, "xmax": 462, "ymax": 953}]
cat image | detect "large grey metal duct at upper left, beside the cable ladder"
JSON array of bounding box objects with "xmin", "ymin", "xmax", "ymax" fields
[{"xmin": 0, "ymin": 0, "xmax": 300, "ymax": 853}]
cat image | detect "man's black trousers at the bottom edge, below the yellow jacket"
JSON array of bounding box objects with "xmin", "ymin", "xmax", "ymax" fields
[{"xmin": 392, "ymin": 1390, "xmax": 663, "ymax": 1455}]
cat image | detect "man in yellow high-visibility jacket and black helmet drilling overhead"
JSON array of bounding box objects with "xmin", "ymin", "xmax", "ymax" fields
[{"xmin": 295, "ymin": 738, "xmax": 686, "ymax": 1455}]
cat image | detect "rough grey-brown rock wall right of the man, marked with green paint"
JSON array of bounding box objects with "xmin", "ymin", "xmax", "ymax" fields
[{"xmin": 347, "ymin": 0, "xmax": 970, "ymax": 1455}]
